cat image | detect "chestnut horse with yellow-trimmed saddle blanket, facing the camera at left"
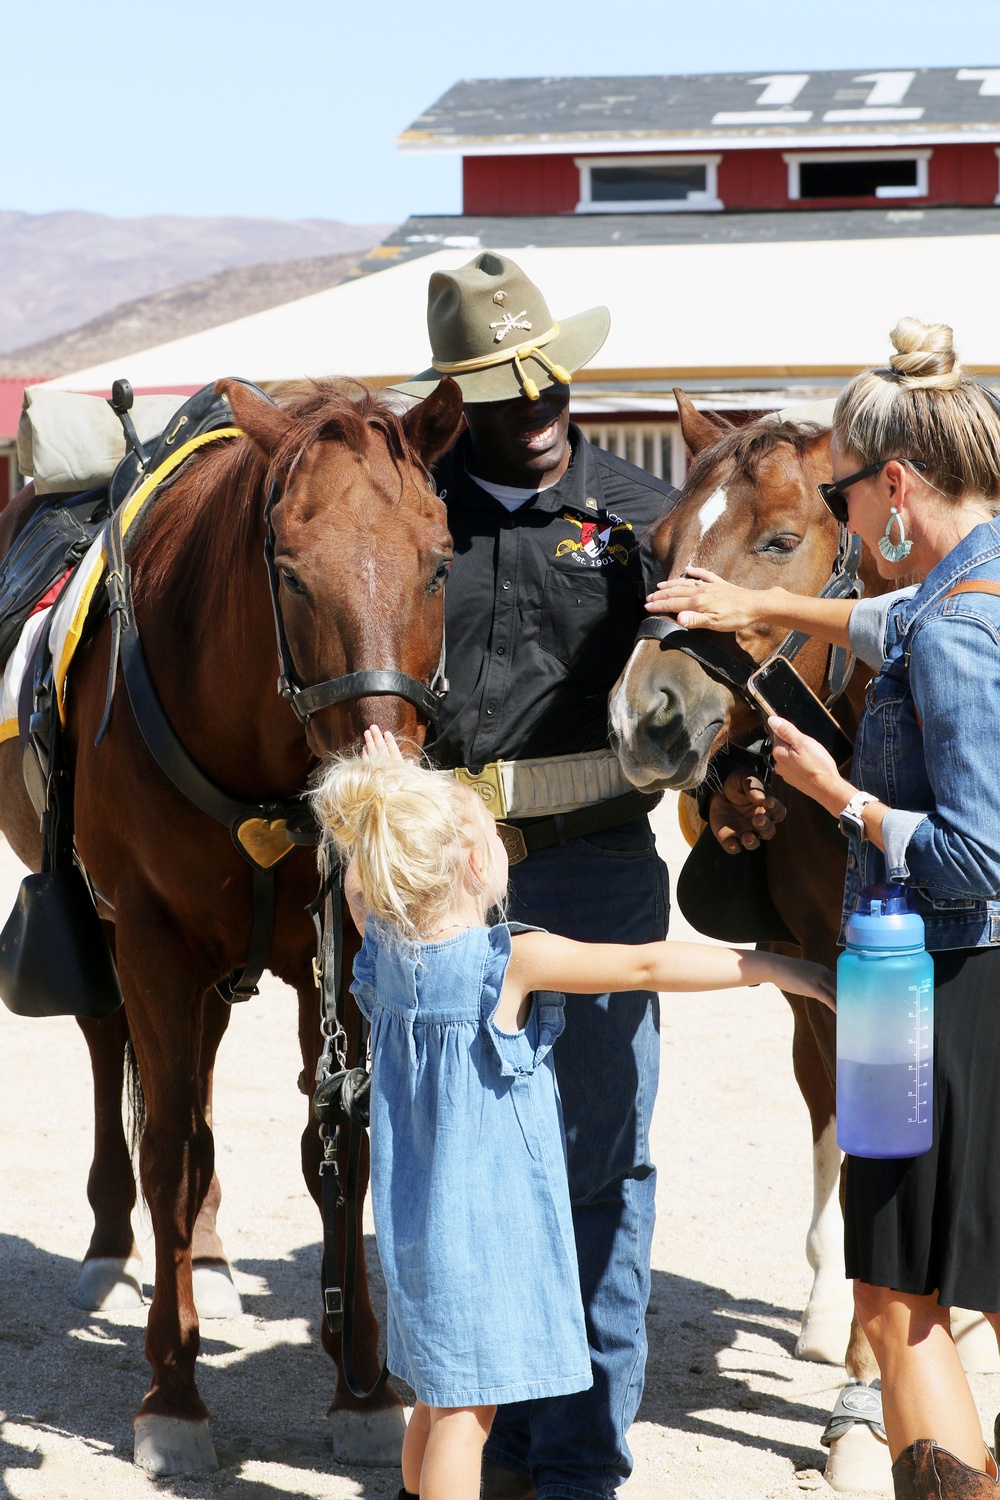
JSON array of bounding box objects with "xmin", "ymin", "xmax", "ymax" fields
[{"xmin": 0, "ymin": 381, "xmax": 462, "ymax": 1475}]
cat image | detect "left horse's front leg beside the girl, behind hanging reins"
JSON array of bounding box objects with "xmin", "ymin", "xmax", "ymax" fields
[{"xmin": 298, "ymin": 984, "xmax": 406, "ymax": 1467}]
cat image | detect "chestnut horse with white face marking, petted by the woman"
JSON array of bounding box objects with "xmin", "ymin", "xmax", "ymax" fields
[{"xmin": 610, "ymin": 392, "xmax": 891, "ymax": 1490}]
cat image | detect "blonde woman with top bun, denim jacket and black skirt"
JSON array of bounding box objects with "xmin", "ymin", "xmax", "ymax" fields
[{"xmin": 648, "ymin": 318, "xmax": 1000, "ymax": 1500}]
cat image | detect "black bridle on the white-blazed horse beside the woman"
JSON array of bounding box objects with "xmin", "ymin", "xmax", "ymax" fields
[{"xmin": 636, "ymin": 527, "xmax": 865, "ymax": 723}]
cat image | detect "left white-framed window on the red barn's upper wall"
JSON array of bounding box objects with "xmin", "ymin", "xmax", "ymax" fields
[{"xmin": 574, "ymin": 156, "xmax": 723, "ymax": 213}]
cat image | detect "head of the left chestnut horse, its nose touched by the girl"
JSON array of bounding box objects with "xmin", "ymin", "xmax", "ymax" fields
[{"xmin": 217, "ymin": 370, "xmax": 462, "ymax": 756}]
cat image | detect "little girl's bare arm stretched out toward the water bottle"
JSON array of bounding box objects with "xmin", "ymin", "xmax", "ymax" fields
[{"xmin": 496, "ymin": 933, "xmax": 837, "ymax": 1029}]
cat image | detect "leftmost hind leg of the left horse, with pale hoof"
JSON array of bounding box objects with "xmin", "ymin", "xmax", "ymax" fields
[{"xmin": 73, "ymin": 1007, "xmax": 142, "ymax": 1313}]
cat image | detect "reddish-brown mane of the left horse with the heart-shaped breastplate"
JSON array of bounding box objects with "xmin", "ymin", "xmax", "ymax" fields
[{"xmin": 130, "ymin": 381, "xmax": 426, "ymax": 620}]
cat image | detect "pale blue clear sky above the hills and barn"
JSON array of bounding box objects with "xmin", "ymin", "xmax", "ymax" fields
[{"xmin": 7, "ymin": 0, "xmax": 1000, "ymax": 224}]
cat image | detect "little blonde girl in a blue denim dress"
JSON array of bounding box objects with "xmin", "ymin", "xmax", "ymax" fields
[{"xmin": 315, "ymin": 728, "xmax": 834, "ymax": 1500}]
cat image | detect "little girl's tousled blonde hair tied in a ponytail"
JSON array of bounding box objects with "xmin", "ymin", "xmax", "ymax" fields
[{"xmin": 312, "ymin": 756, "xmax": 501, "ymax": 939}]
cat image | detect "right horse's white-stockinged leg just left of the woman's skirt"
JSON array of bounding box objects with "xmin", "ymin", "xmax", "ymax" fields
[{"xmin": 786, "ymin": 995, "xmax": 853, "ymax": 1365}]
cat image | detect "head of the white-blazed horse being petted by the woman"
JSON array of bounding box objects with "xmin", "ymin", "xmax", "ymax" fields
[{"xmin": 609, "ymin": 392, "xmax": 869, "ymax": 789}]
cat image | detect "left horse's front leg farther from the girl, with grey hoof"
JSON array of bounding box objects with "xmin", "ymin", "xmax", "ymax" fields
[{"xmin": 117, "ymin": 912, "xmax": 219, "ymax": 1475}]
